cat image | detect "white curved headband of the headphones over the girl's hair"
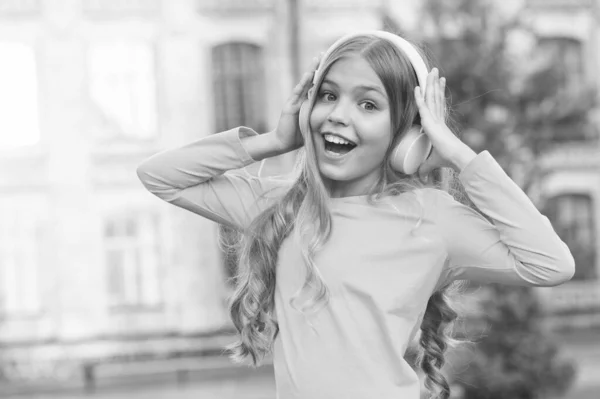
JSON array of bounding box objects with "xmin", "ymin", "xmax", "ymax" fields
[{"xmin": 313, "ymin": 30, "xmax": 429, "ymax": 93}]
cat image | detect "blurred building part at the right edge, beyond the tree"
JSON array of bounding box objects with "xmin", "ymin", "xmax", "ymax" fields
[{"xmin": 525, "ymin": 0, "xmax": 600, "ymax": 330}]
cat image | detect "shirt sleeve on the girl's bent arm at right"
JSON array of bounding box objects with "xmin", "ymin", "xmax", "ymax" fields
[{"xmin": 434, "ymin": 151, "xmax": 575, "ymax": 287}]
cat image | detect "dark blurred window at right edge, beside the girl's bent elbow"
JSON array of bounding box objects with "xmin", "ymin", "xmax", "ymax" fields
[{"xmin": 544, "ymin": 194, "xmax": 598, "ymax": 280}]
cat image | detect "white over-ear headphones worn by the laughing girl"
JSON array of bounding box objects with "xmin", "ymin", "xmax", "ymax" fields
[{"xmin": 298, "ymin": 30, "xmax": 433, "ymax": 175}]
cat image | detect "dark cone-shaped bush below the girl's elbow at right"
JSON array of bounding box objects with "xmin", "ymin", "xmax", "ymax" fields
[{"xmin": 455, "ymin": 284, "xmax": 575, "ymax": 399}]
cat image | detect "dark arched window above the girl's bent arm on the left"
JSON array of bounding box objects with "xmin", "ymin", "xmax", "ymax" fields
[{"xmin": 212, "ymin": 43, "xmax": 266, "ymax": 132}]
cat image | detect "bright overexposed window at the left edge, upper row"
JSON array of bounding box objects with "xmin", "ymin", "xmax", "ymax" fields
[{"xmin": 0, "ymin": 43, "xmax": 40, "ymax": 150}]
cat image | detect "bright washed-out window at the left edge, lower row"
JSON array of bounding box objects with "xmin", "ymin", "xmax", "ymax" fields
[{"xmin": 0, "ymin": 204, "xmax": 41, "ymax": 316}]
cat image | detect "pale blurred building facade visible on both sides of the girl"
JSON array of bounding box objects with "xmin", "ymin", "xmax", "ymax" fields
[{"xmin": 0, "ymin": 0, "xmax": 600, "ymax": 379}]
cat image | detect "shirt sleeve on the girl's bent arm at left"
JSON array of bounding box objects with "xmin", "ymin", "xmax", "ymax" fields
[{"xmin": 137, "ymin": 127, "xmax": 296, "ymax": 229}]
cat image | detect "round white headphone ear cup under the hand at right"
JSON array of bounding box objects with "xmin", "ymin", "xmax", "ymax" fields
[{"xmin": 390, "ymin": 125, "xmax": 433, "ymax": 175}]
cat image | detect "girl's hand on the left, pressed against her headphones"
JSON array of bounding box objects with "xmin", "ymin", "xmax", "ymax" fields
[{"xmin": 274, "ymin": 54, "xmax": 322, "ymax": 152}]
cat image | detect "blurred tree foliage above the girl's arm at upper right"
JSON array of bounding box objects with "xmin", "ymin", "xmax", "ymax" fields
[{"xmin": 421, "ymin": 0, "xmax": 597, "ymax": 190}]
